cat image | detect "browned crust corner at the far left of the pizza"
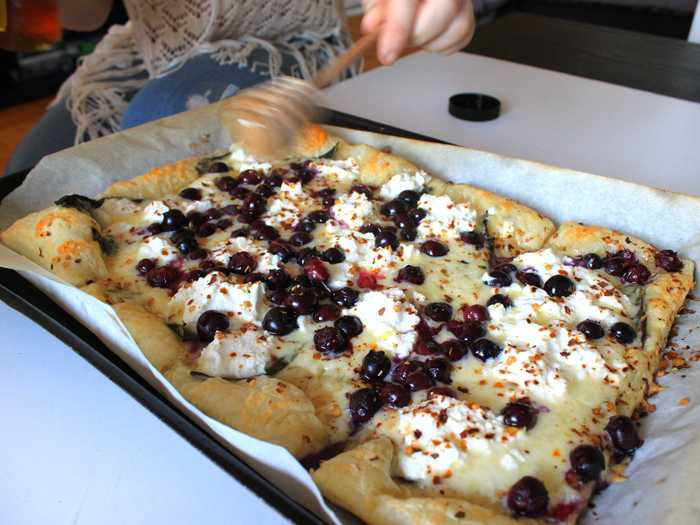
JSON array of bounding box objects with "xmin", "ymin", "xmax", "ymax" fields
[{"xmin": 0, "ymin": 206, "xmax": 107, "ymax": 286}]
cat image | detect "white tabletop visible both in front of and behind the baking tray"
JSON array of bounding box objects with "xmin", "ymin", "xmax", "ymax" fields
[{"xmin": 0, "ymin": 50, "xmax": 700, "ymax": 525}]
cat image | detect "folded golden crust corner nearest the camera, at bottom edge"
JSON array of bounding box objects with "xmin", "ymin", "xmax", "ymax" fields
[{"xmin": 311, "ymin": 438, "xmax": 537, "ymax": 525}]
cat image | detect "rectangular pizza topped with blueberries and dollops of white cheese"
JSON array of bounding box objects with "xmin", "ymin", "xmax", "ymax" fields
[{"xmin": 1, "ymin": 126, "xmax": 693, "ymax": 524}]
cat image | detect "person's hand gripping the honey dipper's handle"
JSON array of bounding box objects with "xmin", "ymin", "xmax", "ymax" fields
[{"xmin": 362, "ymin": 0, "xmax": 474, "ymax": 65}]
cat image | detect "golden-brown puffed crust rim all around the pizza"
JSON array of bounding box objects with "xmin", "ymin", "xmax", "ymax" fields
[{"xmin": 0, "ymin": 127, "xmax": 693, "ymax": 525}]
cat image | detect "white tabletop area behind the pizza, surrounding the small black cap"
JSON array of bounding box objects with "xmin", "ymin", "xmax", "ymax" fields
[{"xmin": 326, "ymin": 53, "xmax": 700, "ymax": 195}]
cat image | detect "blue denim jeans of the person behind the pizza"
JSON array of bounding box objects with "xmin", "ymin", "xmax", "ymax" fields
[{"xmin": 6, "ymin": 49, "xmax": 295, "ymax": 173}]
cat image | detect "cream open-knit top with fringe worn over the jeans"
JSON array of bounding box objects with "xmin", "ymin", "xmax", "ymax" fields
[{"xmin": 54, "ymin": 0, "xmax": 349, "ymax": 143}]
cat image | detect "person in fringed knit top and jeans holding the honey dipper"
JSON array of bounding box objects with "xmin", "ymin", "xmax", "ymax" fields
[{"xmin": 6, "ymin": 0, "xmax": 475, "ymax": 173}]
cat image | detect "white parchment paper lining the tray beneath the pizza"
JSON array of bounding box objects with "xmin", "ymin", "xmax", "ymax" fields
[{"xmin": 0, "ymin": 100, "xmax": 700, "ymax": 525}]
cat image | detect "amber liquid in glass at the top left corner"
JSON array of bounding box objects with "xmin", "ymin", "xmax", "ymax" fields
[{"xmin": 0, "ymin": 0, "xmax": 61, "ymax": 51}]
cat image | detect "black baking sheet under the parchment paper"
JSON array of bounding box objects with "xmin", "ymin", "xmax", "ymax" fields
[{"xmin": 0, "ymin": 110, "xmax": 441, "ymax": 525}]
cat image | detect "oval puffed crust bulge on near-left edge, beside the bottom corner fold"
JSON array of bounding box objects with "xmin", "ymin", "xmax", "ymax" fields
[{"xmin": 175, "ymin": 376, "xmax": 328, "ymax": 458}]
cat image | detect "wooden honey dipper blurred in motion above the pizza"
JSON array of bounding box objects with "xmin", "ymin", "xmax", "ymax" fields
[{"xmin": 219, "ymin": 32, "xmax": 379, "ymax": 158}]
